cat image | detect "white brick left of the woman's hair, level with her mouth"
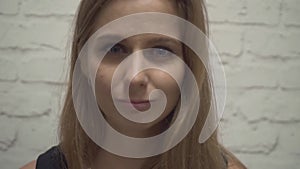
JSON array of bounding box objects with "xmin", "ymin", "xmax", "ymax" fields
[{"xmin": 0, "ymin": 84, "xmax": 58, "ymax": 118}]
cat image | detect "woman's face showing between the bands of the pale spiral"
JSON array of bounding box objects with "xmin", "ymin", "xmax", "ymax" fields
[{"xmin": 95, "ymin": 0, "xmax": 184, "ymax": 137}]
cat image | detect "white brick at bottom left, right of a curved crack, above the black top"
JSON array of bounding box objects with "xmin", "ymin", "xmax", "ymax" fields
[{"xmin": 0, "ymin": 115, "xmax": 57, "ymax": 168}]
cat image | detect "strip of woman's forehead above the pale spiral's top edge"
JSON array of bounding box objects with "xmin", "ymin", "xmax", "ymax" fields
[{"xmin": 95, "ymin": 0, "xmax": 180, "ymax": 29}]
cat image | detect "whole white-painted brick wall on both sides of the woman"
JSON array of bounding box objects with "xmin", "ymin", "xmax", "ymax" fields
[{"xmin": 0, "ymin": 0, "xmax": 300, "ymax": 169}]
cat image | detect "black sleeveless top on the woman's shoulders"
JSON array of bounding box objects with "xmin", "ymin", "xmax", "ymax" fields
[{"xmin": 36, "ymin": 145, "xmax": 228, "ymax": 169}]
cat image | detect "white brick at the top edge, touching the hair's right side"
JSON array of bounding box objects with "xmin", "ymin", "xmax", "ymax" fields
[{"xmin": 208, "ymin": 0, "xmax": 280, "ymax": 25}]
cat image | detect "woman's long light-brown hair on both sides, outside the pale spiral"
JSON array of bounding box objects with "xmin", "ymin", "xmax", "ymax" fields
[{"xmin": 59, "ymin": 0, "xmax": 244, "ymax": 169}]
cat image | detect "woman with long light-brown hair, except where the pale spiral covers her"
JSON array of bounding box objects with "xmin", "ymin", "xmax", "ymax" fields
[{"xmin": 22, "ymin": 0, "xmax": 246, "ymax": 169}]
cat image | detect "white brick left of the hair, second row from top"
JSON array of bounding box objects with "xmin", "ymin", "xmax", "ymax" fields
[{"xmin": 0, "ymin": 20, "xmax": 70, "ymax": 50}]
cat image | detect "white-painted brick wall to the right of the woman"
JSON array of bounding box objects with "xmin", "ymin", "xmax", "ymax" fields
[{"xmin": 208, "ymin": 0, "xmax": 300, "ymax": 169}]
